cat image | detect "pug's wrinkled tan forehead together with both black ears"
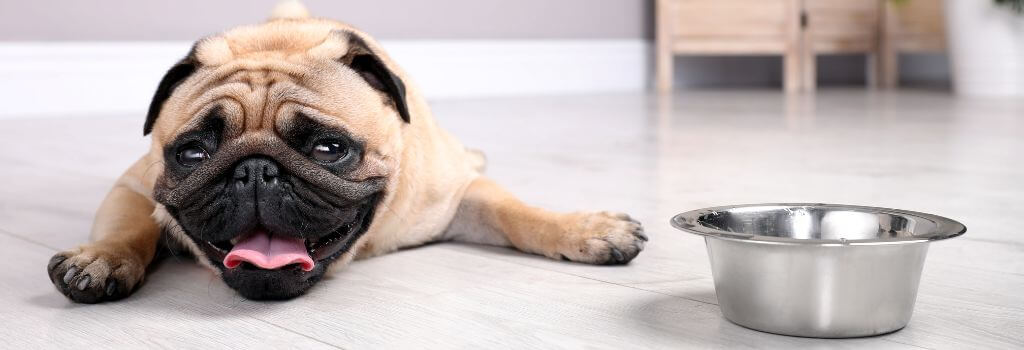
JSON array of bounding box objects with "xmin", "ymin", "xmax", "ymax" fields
[{"xmin": 144, "ymin": 20, "xmax": 410, "ymax": 150}]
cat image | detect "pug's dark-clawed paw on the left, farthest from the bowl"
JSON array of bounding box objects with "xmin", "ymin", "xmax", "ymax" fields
[{"xmin": 46, "ymin": 245, "xmax": 145, "ymax": 304}]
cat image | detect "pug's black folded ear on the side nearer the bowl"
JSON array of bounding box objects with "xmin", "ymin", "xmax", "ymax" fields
[{"xmin": 338, "ymin": 33, "xmax": 411, "ymax": 123}]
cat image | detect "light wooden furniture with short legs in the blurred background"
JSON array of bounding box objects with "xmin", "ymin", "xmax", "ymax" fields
[{"xmin": 655, "ymin": 0, "xmax": 944, "ymax": 91}]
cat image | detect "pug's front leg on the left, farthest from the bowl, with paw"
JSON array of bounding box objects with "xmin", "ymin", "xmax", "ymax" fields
[{"xmin": 46, "ymin": 162, "xmax": 160, "ymax": 303}]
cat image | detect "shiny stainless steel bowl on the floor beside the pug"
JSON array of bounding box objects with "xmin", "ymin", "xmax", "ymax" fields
[{"xmin": 672, "ymin": 204, "xmax": 967, "ymax": 338}]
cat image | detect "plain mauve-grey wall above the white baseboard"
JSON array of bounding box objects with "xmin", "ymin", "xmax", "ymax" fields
[{"xmin": 0, "ymin": 0, "xmax": 652, "ymax": 41}]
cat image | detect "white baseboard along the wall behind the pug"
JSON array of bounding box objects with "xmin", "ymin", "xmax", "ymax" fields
[{"xmin": 0, "ymin": 39, "xmax": 650, "ymax": 118}]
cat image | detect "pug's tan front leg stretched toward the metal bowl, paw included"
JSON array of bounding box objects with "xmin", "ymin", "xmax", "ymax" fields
[{"xmin": 444, "ymin": 176, "xmax": 647, "ymax": 264}]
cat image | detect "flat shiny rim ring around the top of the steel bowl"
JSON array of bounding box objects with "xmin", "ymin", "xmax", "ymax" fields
[{"xmin": 670, "ymin": 203, "xmax": 967, "ymax": 247}]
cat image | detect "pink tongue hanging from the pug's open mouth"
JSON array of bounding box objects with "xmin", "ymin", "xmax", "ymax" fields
[{"xmin": 224, "ymin": 230, "xmax": 314, "ymax": 271}]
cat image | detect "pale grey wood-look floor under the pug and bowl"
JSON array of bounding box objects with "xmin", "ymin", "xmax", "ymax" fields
[{"xmin": 0, "ymin": 90, "xmax": 1024, "ymax": 349}]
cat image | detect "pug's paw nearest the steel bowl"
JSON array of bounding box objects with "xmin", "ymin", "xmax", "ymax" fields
[{"xmin": 558, "ymin": 212, "xmax": 647, "ymax": 264}]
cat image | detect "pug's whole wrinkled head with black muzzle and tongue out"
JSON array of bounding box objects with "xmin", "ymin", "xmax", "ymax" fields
[{"xmin": 144, "ymin": 7, "xmax": 416, "ymax": 299}]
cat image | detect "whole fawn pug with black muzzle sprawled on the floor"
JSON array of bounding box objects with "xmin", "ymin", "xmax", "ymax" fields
[{"xmin": 47, "ymin": 1, "xmax": 647, "ymax": 303}]
